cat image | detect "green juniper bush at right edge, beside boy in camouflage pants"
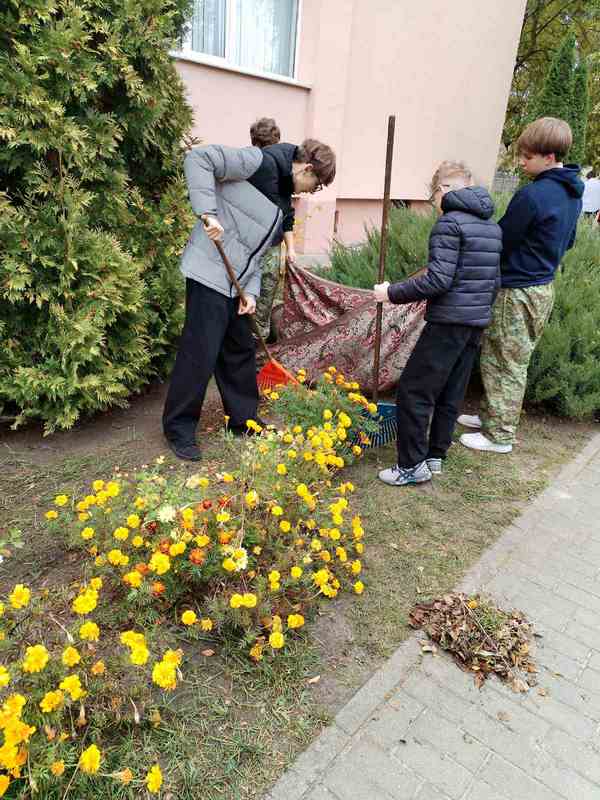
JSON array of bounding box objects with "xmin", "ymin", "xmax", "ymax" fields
[{"xmin": 527, "ymin": 220, "xmax": 600, "ymax": 418}]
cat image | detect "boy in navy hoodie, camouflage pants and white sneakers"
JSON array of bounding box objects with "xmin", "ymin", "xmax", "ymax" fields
[{"xmin": 458, "ymin": 117, "xmax": 584, "ymax": 453}]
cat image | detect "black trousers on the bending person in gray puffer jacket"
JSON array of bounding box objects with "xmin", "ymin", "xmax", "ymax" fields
[{"xmin": 163, "ymin": 278, "xmax": 258, "ymax": 444}]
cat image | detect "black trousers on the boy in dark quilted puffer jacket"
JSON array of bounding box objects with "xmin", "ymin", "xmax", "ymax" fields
[{"xmin": 396, "ymin": 322, "xmax": 483, "ymax": 467}]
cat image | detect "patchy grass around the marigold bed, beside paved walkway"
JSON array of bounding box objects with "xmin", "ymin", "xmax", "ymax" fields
[{"xmin": 0, "ymin": 410, "xmax": 589, "ymax": 800}]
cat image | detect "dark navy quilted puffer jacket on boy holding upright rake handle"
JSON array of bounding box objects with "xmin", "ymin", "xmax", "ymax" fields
[{"xmin": 388, "ymin": 186, "xmax": 502, "ymax": 328}]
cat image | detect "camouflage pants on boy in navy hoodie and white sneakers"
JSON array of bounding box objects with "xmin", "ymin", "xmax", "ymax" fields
[{"xmin": 480, "ymin": 283, "xmax": 554, "ymax": 444}]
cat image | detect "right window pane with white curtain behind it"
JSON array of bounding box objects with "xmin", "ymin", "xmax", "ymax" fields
[{"xmin": 230, "ymin": 0, "xmax": 298, "ymax": 76}]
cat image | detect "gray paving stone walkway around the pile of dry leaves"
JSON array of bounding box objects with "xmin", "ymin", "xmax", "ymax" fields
[{"xmin": 266, "ymin": 435, "xmax": 600, "ymax": 800}]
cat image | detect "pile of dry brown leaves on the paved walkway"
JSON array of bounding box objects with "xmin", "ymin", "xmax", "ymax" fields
[{"xmin": 410, "ymin": 593, "xmax": 537, "ymax": 692}]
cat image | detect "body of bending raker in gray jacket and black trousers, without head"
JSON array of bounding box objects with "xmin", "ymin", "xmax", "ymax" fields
[{"xmin": 163, "ymin": 145, "xmax": 282, "ymax": 461}]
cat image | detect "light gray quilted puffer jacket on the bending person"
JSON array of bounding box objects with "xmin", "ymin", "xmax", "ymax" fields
[{"xmin": 181, "ymin": 145, "xmax": 282, "ymax": 298}]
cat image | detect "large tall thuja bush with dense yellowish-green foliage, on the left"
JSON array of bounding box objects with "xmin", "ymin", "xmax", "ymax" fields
[{"xmin": 0, "ymin": 0, "xmax": 192, "ymax": 432}]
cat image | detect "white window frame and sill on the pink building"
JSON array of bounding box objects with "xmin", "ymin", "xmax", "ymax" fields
[{"xmin": 171, "ymin": 0, "xmax": 310, "ymax": 89}]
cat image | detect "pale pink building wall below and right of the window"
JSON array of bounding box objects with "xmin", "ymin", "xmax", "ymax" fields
[{"xmin": 178, "ymin": 0, "xmax": 526, "ymax": 254}]
